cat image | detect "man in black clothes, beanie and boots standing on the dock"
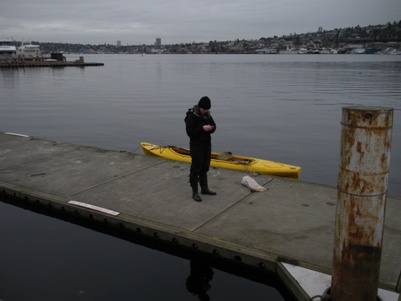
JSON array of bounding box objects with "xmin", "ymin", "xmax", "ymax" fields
[{"xmin": 185, "ymin": 96, "xmax": 216, "ymax": 202}]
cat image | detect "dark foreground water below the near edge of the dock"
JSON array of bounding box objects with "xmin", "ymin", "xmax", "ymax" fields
[{"xmin": 0, "ymin": 199, "xmax": 291, "ymax": 301}]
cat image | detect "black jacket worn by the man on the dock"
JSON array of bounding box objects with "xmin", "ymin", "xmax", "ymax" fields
[{"xmin": 185, "ymin": 106, "xmax": 216, "ymax": 148}]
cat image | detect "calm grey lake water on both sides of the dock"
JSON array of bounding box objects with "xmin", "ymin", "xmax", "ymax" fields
[{"xmin": 0, "ymin": 55, "xmax": 401, "ymax": 301}]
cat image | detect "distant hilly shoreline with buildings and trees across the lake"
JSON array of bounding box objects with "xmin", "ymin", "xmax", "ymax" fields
[{"xmin": 32, "ymin": 20, "xmax": 401, "ymax": 54}]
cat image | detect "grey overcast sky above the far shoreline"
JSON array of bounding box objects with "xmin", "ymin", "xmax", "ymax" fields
[{"xmin": 0, "ymin": 0, "xmax": 401, "ymax": 45}]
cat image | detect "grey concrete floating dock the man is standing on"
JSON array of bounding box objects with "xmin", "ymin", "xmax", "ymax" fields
[{"xmin": 0, "ymin": 133, "xmax": 401, "ymax": 301}]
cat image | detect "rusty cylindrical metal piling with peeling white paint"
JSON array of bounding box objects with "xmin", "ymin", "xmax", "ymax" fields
[{"xmin": 330, "ymin": 106, "xmax": 393, "ymax": 301}]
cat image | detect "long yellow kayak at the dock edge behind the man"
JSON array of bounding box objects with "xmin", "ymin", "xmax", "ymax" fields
[{"xmin": 141, "ymin": 142, "xmax": 301, "ymax": 179}]
